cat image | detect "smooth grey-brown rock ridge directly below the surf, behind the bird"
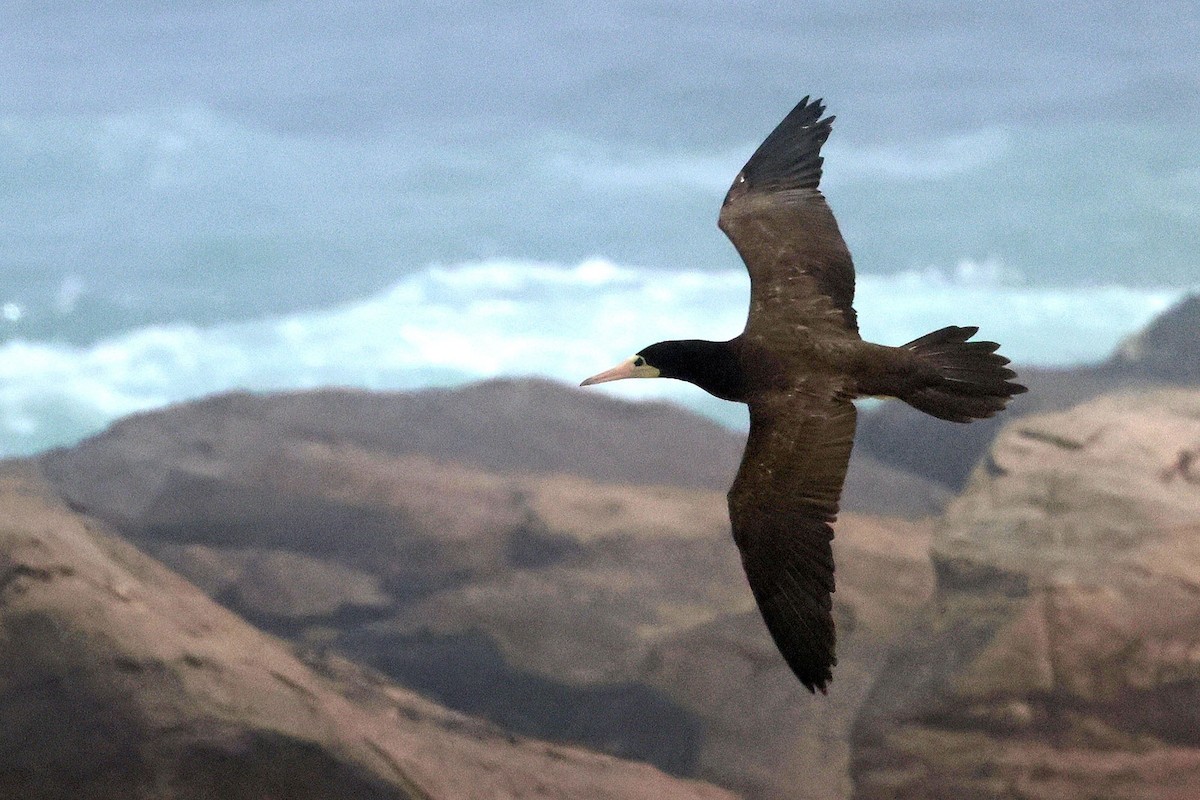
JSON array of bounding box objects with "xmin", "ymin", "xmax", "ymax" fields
[{"xmin": 43, "ymin": 379, "xmax": 955, "ymax": 518}]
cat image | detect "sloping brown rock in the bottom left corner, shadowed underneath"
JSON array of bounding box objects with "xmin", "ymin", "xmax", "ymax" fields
[{"xmin": 0, "ymin": 464, "xmax": 732, "ymax": 800}]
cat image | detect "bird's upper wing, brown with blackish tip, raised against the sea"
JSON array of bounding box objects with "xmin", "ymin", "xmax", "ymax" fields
[{"xmin": 718, "ymin": 97, "xmax": 858, "ymax": 332}]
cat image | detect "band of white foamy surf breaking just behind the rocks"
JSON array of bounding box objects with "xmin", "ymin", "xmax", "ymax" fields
[{"xmin": 0, "ymin": 259, "xmax": 1182, "ymax": 455}]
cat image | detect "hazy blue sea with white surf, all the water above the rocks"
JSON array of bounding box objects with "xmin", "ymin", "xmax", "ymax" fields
[{"xmin": 0, "ymin": 0, "xmax": 1200, "ymax": 455}]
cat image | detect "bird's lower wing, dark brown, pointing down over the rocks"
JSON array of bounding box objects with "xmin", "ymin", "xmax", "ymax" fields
[{"xmin": 730, "ymin": 386, "xmax": 856, "ymax": 692}]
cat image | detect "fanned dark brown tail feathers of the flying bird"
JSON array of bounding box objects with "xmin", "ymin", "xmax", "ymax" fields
[{"xmin": 901, "ymin": 325, "xmax": 1026, "ymax": 422}]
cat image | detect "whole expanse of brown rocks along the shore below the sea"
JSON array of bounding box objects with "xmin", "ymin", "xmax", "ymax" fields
[{"xmin": 14, "ymin": 291, "xmax": 1200, "ymax": 800}]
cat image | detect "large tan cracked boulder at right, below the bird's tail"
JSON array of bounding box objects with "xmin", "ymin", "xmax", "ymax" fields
[{"xmin": 852, "ymin": 390, "xmax": 1200, "ymax": 800}]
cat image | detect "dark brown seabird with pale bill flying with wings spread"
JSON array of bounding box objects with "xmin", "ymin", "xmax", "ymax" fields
[{"xmin": 582, "ymin": 97, "xmax": 1026, "ymax": 692}]
